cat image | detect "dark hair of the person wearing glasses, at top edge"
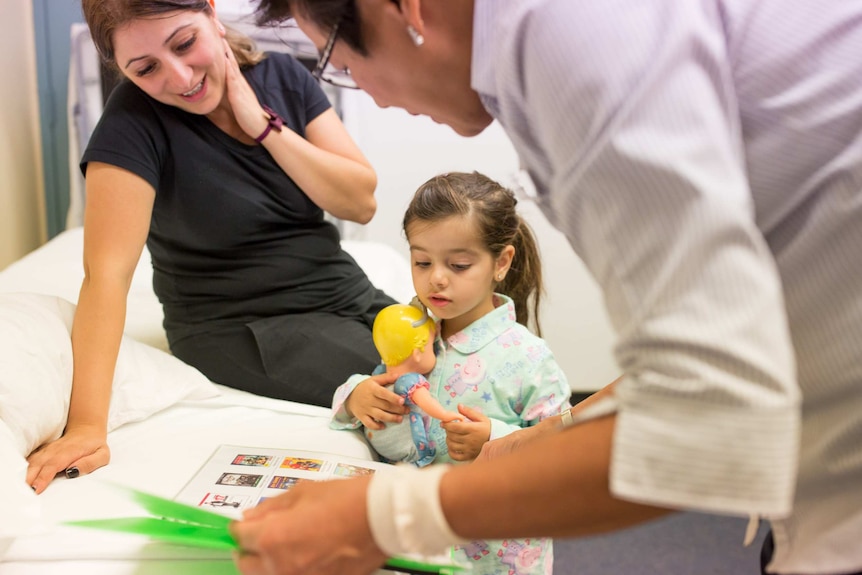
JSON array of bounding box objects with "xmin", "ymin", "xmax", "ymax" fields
[{"xmin": 252, "ymin": 0, "xmax": 368, "ymax": 56}]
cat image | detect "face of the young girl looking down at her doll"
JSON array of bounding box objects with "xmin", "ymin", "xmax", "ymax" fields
[{"xmin": 406, "ymin": 216, "xmax": 513, "ymax": 338}]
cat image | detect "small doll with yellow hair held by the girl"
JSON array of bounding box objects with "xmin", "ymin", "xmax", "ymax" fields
[{"xmin": 365, "ymin": 304, "xmax": 463, "ymax": 467}]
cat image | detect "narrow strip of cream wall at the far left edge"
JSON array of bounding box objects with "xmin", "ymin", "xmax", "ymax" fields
[{"xmin": 0, "ymin": 0, "xmax": 45, "ymax": 269}]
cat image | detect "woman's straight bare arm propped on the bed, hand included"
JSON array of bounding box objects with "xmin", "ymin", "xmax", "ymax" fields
[{"xmin": 27, "ymin": 162, "xmax": 155, "ymax": 493}]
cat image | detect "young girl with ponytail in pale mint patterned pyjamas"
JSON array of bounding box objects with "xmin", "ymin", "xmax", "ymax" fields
[{"xmin": 333, "ymin": 172, "xmax": 571, "ymax": 575}]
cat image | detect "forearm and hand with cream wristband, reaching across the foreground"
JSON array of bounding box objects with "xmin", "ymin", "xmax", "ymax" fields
[{"xmin": 231, "ymin": 417, "xmax": 668, "ymax": 575}]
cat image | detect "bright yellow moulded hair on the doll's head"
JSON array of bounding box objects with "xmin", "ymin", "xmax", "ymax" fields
[{"xmin": 371, "ymin": 303, "xmax": 434, "ymax": 366}]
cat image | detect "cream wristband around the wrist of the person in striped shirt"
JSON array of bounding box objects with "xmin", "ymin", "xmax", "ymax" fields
[{"xmin": 368, "ymin": 465, "xmax": 466, "ymax": 556}]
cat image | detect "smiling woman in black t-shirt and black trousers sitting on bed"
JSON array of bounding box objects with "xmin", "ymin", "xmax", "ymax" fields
[{"xmin": 28, "ymin": 0, "xmax": 394, "ymax": 492}]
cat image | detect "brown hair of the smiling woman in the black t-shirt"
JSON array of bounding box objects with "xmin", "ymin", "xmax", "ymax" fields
[{"xmin": 81, "ymin": 0, "xmax": 265, "ymax": 71}]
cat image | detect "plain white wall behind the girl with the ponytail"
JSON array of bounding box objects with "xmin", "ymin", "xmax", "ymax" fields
[{"xmin": 342, "ymin": 91, "xmax": 619, "ymax": 391}]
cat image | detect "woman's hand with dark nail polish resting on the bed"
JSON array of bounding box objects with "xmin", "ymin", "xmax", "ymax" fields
[{"xmin": 27, "ymin": 426, "xmax": 111, "ymax": 493}]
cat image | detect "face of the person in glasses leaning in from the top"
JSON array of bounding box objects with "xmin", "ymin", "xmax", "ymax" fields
[{"xmin": 295, "ymin": 0, "xmax": 492, "ymax": 136}]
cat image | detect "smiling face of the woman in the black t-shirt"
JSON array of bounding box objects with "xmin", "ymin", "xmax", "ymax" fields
[{"xmin": 114, "ymin": 11, "xmax": 228, "ymax": 114}]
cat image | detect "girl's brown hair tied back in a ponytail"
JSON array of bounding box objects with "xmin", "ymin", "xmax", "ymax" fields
[{"xmin": 402, "ymin": 172, "xmax": 543, "ymax": 336}]
